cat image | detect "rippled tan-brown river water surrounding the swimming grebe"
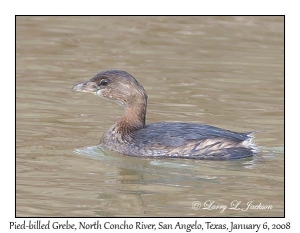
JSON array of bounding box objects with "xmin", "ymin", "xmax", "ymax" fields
[{"xmin": 16, "ymin": 16, "xmax": 284, "ymax": 217}]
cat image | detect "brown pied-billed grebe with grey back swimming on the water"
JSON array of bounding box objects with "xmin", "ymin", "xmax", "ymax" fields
[{"xmin": 73, "ymin": 70, "xmax": 257, "ymax": 160}]
